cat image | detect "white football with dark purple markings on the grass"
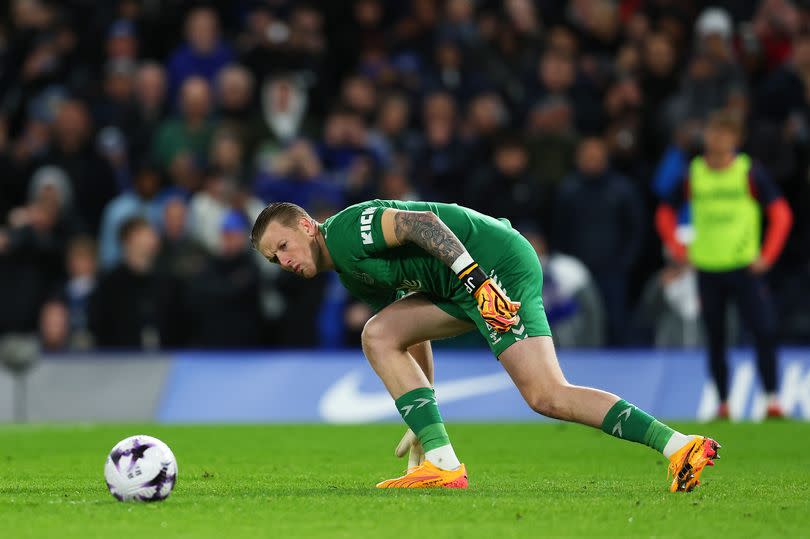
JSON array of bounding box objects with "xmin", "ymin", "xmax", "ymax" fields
[{"xmin": 104, "ymin": 434, "xmax": 177, "ymax": 502}]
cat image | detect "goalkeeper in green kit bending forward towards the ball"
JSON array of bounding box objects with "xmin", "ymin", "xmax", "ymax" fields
[{"xmin": 251, "ymin": 200, "xmax": 718, "ymax": 491}]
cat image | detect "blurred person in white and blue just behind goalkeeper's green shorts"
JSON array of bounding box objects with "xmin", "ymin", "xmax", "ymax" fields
[{"xmin": 520, "ymin": 224, "xmax": 605, "ymax": 348}]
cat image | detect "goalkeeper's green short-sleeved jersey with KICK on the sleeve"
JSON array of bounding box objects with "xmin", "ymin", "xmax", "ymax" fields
[{"xmin": 321, "ymin": 200, "xmax": 519, "ymax": 310}]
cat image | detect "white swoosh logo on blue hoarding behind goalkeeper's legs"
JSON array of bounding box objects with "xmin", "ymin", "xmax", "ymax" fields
[{"xmin": 318, "ymin": 371, "xmax": 513, "ymax": 423}]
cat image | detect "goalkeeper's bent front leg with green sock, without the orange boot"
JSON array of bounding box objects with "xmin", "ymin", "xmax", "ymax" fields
[{"xmin": 362, "ymin": 294, "xmax": 473, "ymax": 480}]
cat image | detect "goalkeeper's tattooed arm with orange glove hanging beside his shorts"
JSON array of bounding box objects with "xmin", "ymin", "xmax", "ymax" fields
[{"xmin": 380, "ymin": 208, "xmax": 520, "ymax": 332}]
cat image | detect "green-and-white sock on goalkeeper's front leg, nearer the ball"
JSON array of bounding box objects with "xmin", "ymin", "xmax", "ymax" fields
[{"xmin": 396, "ymin": 387, "xmax": 461, "ymax": 470}]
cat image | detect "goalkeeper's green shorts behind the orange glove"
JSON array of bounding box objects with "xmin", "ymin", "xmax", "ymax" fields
[{"xmin": 426, "ymin": 234, "xmax": 551, "ymax": 357}]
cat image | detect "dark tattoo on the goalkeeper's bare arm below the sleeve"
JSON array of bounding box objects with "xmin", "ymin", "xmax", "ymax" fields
[{"xmin": 394, "ymin": 211, "xmax": 465, "ymax": 266}]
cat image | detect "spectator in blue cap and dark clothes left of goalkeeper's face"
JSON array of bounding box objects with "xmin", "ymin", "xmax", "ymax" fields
[{"xmin": 189, "ymin": 210, "xmax": 262, "ymax": 348}]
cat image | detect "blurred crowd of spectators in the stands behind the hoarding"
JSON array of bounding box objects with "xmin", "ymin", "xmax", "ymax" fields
[{"xmin": 0, "ymin": 0, "xmax": 810, "ymax": 350}]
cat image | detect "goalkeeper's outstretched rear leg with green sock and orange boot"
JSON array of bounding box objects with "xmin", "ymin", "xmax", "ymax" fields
[{"xmin": 499, "ymin": 336, "xmax": 718, "ymax": 491}]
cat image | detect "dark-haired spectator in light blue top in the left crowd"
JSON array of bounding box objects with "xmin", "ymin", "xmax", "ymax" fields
[{"xmin": 99, "ymin": 162, "xmax": 161, "ymax": 270}]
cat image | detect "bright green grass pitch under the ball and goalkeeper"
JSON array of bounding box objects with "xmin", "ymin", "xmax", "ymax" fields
[{"xmin": 0, "ymin": 422, "xmax": 810, "ymax": 539}]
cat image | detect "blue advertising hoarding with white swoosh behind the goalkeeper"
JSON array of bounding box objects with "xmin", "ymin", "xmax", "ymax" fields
[{"xmin": 157, "ymin": 349, "xmax": 810, "ymax": 423}]
